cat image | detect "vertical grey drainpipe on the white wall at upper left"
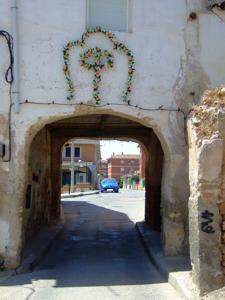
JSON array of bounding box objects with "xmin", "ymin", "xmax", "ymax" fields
[{"xmin": 11, "ymin": 0, "xmax": 20, "ymax": 113}]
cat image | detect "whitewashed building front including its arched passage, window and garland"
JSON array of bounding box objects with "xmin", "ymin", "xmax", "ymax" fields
[{"xmin": 0, "ymin": 0, "xmax": 225, "ymax": 294}]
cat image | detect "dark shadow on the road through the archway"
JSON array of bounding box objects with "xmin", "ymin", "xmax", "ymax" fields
[{"xmin": 1, "ymin": 200, "xmax": 165, "ymax": 287}]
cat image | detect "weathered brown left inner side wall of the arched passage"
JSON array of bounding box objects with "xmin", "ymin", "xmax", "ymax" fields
[{"xmin": 23, "ymin": 128, "xmax": 51, "ymax": 240}]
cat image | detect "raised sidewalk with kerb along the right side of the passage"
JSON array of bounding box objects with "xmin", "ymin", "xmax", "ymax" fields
[{"xmin": 136, "ymin": 222, "xmax": 199, "ymax": 300}]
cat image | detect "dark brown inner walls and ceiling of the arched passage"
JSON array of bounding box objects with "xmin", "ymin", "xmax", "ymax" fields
[{"xmin": 23, "ymin": 114, "xmax": 164, "ymax": 244}]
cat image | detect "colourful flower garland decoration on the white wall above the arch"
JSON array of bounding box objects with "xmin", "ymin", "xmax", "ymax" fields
[{"xmin": 63, "ymin": 27, "xmax": 135, "ymax": 104}]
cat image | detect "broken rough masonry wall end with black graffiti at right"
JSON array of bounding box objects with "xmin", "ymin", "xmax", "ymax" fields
[{"xmin": 188, "ymin": 89, "xmax": 225, "ymax": 293}]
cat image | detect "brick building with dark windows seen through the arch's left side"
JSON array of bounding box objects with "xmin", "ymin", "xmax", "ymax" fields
[{"xmin": 62, "ymin": 139, "xmax": 101, "ymax": 193}]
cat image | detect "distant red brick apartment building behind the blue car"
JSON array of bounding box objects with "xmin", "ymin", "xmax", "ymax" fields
[{"xmin": 108, "ymin": 153, "xmax": 140, "ymax": 180}]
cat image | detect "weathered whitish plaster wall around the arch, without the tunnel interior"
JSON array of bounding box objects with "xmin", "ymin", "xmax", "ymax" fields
[{"xmin": 0, "ymin": 0, "xmax": 225, "ymax": 272}]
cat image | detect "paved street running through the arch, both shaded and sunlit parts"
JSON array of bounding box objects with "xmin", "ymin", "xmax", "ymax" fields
[{"xmin": 0, "ymin": 191, "xmax": 180, "ymax": 300}]
